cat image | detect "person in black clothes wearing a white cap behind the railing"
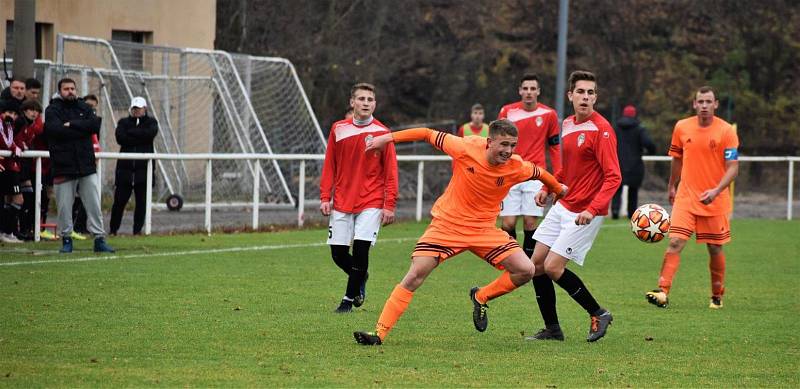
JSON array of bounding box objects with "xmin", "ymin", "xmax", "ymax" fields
[{"xmin": 111, "ymin": 96, "xmax": 158, "ymax": 235}]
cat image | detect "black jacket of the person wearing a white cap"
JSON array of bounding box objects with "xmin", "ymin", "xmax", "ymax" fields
[{"xmin": 115, "ymin": 115, "xmax": 158, "ymax": 185}]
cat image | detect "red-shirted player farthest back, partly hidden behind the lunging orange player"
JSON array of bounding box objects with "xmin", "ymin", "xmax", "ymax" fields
[{"xmin": 497, "ymin": 73, "xmax": 561, "ymax": 257}]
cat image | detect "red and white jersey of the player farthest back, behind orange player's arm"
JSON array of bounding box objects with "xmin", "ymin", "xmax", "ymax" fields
[{"xmin": 497, "ymin": 101, "xmax": 561, "ymax": 171}]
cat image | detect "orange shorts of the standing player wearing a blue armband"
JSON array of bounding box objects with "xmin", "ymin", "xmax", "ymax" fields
[{"xmin": 669, "ymin": 208, "xmax": 731, "ymax": 245}]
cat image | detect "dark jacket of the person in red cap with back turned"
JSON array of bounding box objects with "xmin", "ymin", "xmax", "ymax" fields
[{"xmin": 616, "ymin": 116, "xmax": 656, "ymax": 186}]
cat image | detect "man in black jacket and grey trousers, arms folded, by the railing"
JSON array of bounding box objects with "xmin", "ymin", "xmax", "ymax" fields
[{"xmin": 44, "ymin": 78, "xmax": 114, "ymax": 253}]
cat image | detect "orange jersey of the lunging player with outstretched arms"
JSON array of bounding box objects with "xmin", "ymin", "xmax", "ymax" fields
[{"xmin": 392, "ymin": 128, "xmax": 561, "ymax": 229}]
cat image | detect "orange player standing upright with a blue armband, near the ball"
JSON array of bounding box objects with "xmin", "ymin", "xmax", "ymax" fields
[{"xmin": 646, "ymin": 86, "xmax": 739, "ymax": 309}]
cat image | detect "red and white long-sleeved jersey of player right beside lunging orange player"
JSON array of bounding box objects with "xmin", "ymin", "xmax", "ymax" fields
[{"xmin": 555, "ymin": 112, "xmax": 622, "ymax": 216}]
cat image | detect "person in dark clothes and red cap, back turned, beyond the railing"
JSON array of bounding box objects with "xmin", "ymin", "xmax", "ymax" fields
[{"xmin": 611, "ymin": 105, "xmax": 656, "ymax": 219}]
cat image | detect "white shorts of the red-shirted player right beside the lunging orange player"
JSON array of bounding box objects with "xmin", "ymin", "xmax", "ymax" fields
[{"xmin": 533, "ymin": 202, "xmax": 603, "ymax": 266}]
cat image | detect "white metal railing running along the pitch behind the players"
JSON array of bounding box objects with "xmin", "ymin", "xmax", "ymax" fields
[{"xmin": 0, "ymin": 151, "xmax": 800, "ymax": 241}]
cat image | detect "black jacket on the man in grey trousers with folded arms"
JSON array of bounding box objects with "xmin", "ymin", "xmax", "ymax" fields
[{"xmin": 44, "ymin": 96, "xmax": 101, "ymax": 177}]
